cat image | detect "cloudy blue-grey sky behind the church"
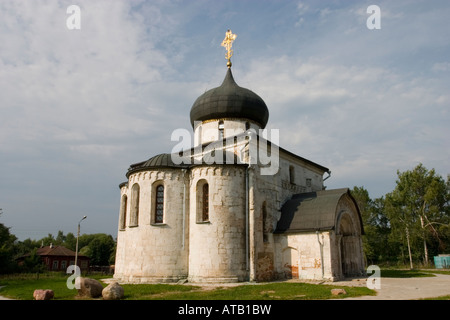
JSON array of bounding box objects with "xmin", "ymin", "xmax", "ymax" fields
[{"xmin": 0, "ymin": 0, "xmax": 450, "ymax": 240}]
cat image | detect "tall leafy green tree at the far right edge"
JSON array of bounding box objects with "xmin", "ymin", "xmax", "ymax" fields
[{"xmin": 385, "ymin": 164, "xmax": 449, "ymax": 268}]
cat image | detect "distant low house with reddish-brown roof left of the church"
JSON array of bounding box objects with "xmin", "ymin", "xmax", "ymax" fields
[{"xmin": 17, "ymin": 244, "xmax": 90, "ymax": 271}]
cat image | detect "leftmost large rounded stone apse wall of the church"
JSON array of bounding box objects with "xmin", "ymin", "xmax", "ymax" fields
[{"xmin": 114, "ymin": 169, "xmax": 189, "ymax": 283}]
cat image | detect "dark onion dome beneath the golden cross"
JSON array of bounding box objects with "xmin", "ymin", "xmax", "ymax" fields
[{"xmin": 191, "ymin": 68, "xmax": 269, "ymax": 128}]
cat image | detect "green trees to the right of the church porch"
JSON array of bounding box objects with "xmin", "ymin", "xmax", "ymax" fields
[{"xmin": 351, "ymin": 164, "xmax": 450, "ymax": 269}]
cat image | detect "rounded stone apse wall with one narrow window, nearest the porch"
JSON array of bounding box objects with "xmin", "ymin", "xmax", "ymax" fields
[{"xmin": 188, "ymin": 166, "xmax": 247, "ymax": 282}]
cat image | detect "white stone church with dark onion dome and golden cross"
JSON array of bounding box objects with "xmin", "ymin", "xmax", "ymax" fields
[{"xmin": 114, "ymin": 32, "xmax": 365, "ymax": 283}]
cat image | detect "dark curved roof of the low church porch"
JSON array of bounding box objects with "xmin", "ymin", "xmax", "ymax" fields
[{"xmin": 274, "ymin": 188, "xmax": 364, "ymax": 233}]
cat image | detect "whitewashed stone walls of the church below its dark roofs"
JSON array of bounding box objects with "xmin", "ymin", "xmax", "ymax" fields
[{"xmin": 114, "ymin": 139, "xmax": 352, "ymax": 283}]
